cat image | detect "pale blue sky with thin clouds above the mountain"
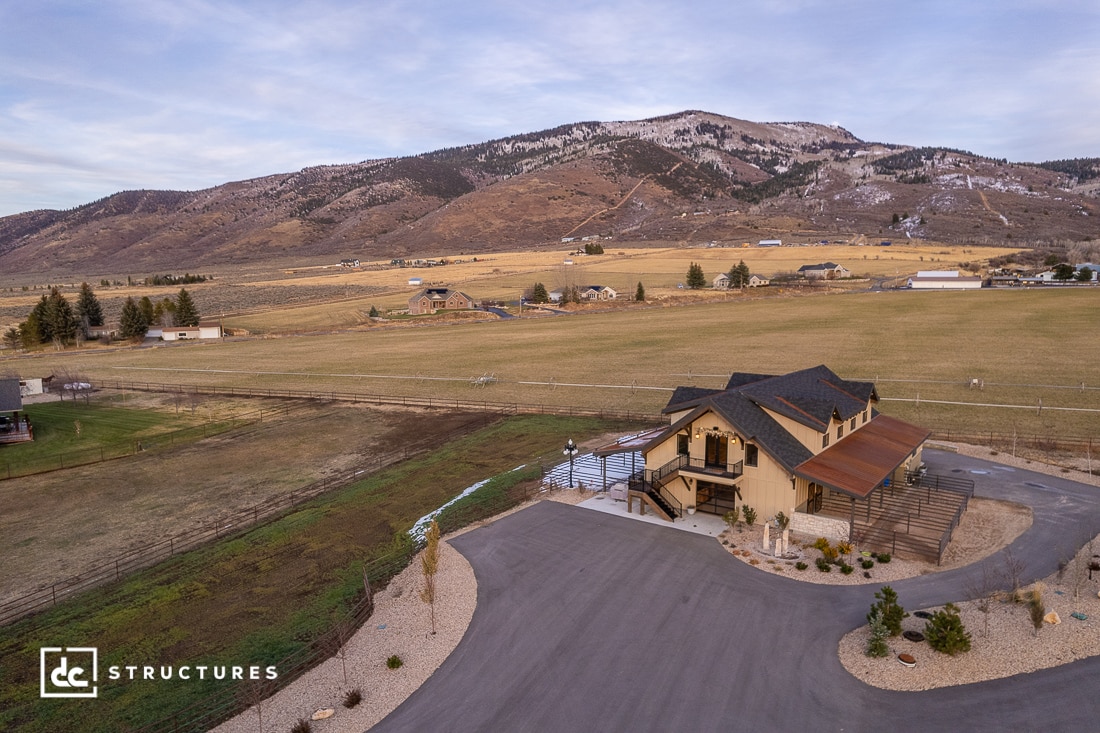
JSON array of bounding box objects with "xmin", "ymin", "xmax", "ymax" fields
[{"xmin": 0, "ymin": 0, "xmax": 1100, "ymax": 216}]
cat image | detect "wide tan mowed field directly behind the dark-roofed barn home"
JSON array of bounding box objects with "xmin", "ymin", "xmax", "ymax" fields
[{"xmin": 9, "ymin": 281, "xmax": 1100, "ymax": 435}]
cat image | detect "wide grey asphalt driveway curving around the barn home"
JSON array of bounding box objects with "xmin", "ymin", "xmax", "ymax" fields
[{"xmin": 367, "ymin": 451, "xmax": 1100, "ymax": 733}]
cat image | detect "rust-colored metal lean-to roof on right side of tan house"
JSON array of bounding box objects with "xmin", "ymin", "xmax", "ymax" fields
[{"xmin": 794, "ymin": 415, "xmax": 932, "ymax": 499}]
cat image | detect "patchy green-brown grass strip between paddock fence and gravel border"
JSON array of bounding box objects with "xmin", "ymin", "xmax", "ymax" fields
[{"xmin": 0, "ymin": 416, "xmax": 629, "ymax": 733}]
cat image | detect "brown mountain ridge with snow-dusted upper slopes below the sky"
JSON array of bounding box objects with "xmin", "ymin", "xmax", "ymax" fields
[{"xmin": 0, "ymin": 111, "xmax": 1100, "ymax": 274}]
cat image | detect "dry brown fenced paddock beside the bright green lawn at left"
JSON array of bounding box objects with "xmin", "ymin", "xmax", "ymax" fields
[{"xmin": 0, "ymin": 394, "xmax": 490, "ymax": 603}]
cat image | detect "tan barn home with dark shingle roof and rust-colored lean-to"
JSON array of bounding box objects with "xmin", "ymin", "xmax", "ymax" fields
[{"xmin": 633, "ymin": 367, "xmax": 931, "ymax": 539}]
